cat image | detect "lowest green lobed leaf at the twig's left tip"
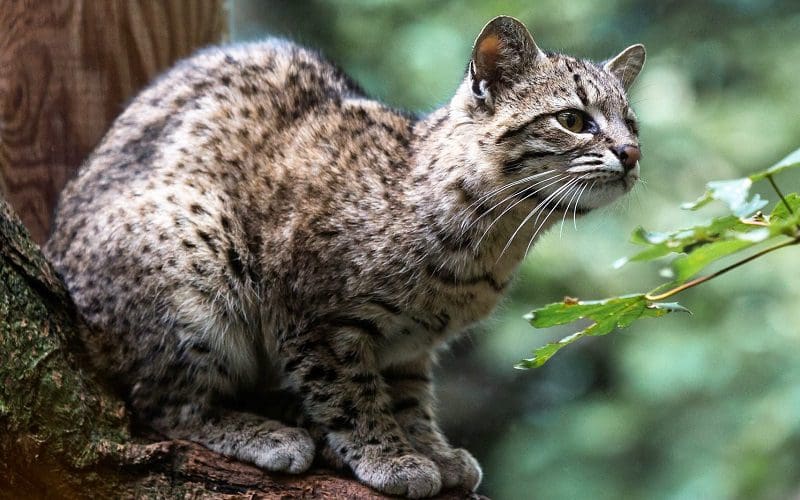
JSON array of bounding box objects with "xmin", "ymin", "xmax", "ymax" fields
[{"xmin": 515, "ymin": 294, "xmax": 688, "ymax": 369}]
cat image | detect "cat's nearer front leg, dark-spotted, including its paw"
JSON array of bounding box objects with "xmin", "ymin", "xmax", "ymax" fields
[{"xmin": 280, "ymin": 318, "xmax": 442, "ymax": 498}]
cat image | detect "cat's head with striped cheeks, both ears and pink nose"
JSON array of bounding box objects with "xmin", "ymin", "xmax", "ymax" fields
[{"xmin": 451, "ymin": 16, "xmax": 645, "ymax": 213}]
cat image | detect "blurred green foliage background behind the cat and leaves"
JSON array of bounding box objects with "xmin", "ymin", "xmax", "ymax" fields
[{"xmin": 231, "ymin": 0, "xmax": 800, "ymax": 499}]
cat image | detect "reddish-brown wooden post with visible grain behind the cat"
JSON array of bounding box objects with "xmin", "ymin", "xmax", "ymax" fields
[{"xmin": 0, "ymin": 0, "xmax": 227, "ymax": 243}]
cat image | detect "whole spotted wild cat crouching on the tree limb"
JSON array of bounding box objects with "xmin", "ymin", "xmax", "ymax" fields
[{"xmin": 45, "ymin": 16, "xmax": 645, "ymax": 498}]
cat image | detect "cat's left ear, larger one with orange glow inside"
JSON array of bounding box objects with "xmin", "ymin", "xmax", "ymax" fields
[{"xmin": 469, "ymin": 16, "xmax": 545, "ymax": 99}]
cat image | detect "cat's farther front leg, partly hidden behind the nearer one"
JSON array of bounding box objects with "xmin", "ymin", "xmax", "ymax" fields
[{"xmin": 381, "ymin": 356, "xmax": 482, "ymax": 490}]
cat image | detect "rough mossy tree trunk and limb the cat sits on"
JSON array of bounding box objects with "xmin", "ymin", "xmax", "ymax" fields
[{"xmin": 0, "ymin": 197, "xmax": 479, "ymax": 499}]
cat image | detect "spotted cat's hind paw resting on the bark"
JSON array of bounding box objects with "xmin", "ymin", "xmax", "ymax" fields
[{"xmin": 255, "ymin": 427, "xmax": 314, "ymax": 474}]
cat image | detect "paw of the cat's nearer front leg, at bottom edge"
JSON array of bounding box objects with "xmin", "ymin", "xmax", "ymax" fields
[{"xmin": 355, "ymin": 455, "xmax": 442, "ymax": 498}]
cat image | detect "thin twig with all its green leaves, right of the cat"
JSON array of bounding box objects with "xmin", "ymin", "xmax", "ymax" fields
[{"xmin": 516, "ymin": 149, "xmax": 800, "ymax": 369}]
